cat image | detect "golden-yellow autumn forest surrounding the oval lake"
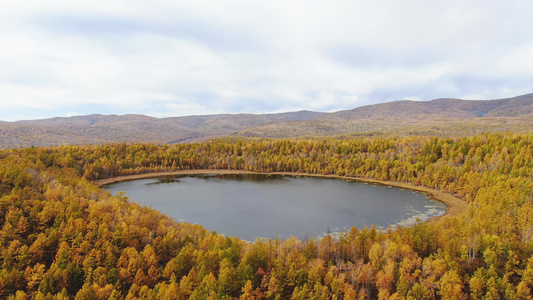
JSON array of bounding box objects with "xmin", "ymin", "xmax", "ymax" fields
[{"xmin": 0, "ymin": 132, "xmax": 533, "ymax": 300}]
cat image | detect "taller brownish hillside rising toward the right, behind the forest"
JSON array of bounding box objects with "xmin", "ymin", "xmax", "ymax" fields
[{"xmin": 235, "ymin": 94, "xmax": 533, "ymax": 138}]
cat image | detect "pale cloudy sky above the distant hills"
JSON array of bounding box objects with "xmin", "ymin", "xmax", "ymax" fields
[{"xmin": 0, "ymin": 0, "xmax": 533, "ymax": 121}]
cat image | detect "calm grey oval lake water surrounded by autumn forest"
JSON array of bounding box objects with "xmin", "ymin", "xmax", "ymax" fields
[{"xmin": 105, "ymin": 174, "xmax": 446, "ymax": 241}]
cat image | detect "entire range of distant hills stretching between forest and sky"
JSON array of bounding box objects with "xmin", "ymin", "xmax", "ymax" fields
[{"xmin": 0, "ymin": 94, "xmax": 533, "ymax": 149}]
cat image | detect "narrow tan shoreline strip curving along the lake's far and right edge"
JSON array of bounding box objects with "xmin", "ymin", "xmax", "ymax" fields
[{"xmin": 92, "ymin": 169, "xmax": 468, "ymax": 222}]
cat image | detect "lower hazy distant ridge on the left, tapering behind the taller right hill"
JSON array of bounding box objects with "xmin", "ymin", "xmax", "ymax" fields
[{"xmin": 0, "ymin": 111, "xmax": 325, "ymax": 149}]
